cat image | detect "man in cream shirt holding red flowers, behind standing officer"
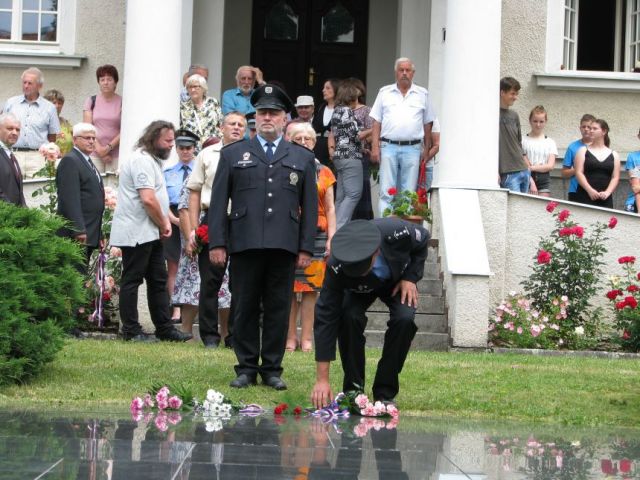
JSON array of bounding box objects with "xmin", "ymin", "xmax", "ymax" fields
[{"xmin": 187, "ymin": 112, "xmax": 247, "ymax": 348}]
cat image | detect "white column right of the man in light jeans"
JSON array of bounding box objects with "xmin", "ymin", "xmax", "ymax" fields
[{"xmin": 434, "ymin": 0, "xmax": 501, "ymax": 188}]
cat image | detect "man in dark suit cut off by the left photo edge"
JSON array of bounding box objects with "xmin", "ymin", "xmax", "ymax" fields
[{"xmin": 0, "ymin": 113, "xmax": 26, "ymax": 207}]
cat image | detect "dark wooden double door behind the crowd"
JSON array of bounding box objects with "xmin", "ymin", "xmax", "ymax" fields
[{"xmin": 251, "ymin": 0, "xmax": 369, "ymax": 104}]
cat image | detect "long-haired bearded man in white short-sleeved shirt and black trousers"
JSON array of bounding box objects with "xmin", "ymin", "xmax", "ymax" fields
[{"xmin": 111, "ymin": 120, "xmax": 191, "ymax": 342}]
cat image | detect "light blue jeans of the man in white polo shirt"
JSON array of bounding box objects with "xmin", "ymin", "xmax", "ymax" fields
[{"xmin": 378, "ymin": 142, "xmax": 422, "ymax": 216}]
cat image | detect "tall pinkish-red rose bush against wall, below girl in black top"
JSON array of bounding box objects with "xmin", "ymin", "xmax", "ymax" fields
[{"xmin": 522, "ymin": 202, "xmax": 618, "ymax": 342}]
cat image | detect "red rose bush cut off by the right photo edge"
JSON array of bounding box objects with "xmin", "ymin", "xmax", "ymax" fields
[{"xmin": 606, "ymin": 256, "xmax": 640, "ymax": 352}]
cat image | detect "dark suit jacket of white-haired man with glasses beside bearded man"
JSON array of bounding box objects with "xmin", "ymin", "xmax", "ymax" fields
[{"xmin": 56, "ymin": 148, "xmax": 104, "ymax": 247}]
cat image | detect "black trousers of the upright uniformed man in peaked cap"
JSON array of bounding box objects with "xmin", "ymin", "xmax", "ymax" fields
[{"xmin": 229, "ymin": 249, "xmax": 296, "ymax": 379}]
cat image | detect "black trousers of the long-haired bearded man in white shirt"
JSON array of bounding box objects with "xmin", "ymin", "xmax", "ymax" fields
[{"xmin": 120, "ymin": 240, "xmax": 173, "ymax": 337}]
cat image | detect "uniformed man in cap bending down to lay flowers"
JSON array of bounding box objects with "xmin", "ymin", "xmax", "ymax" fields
[{"xmin": 311, "ymin": 217, "xmax": 429, "ymax": 408}]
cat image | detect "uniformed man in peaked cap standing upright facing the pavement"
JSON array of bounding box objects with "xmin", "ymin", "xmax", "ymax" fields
[{"xmin": 209, "ymin": 84, "xmax": 318, "ymax": 390}]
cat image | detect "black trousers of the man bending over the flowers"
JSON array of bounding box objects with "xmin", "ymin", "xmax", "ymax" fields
[{"xmin": 338, "ymin": 288, "xmax": 418, "ymax": 400}]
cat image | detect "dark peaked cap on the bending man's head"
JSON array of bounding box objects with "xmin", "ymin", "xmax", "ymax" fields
[{"xmin": 331, "ymin": 220, "xmax": 382, "ymax": 277}]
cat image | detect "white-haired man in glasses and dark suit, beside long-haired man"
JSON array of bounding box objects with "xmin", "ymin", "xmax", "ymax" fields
[{"xmin": 56, "ymin": 123, "xmax": 104, "ymax": 273}]
